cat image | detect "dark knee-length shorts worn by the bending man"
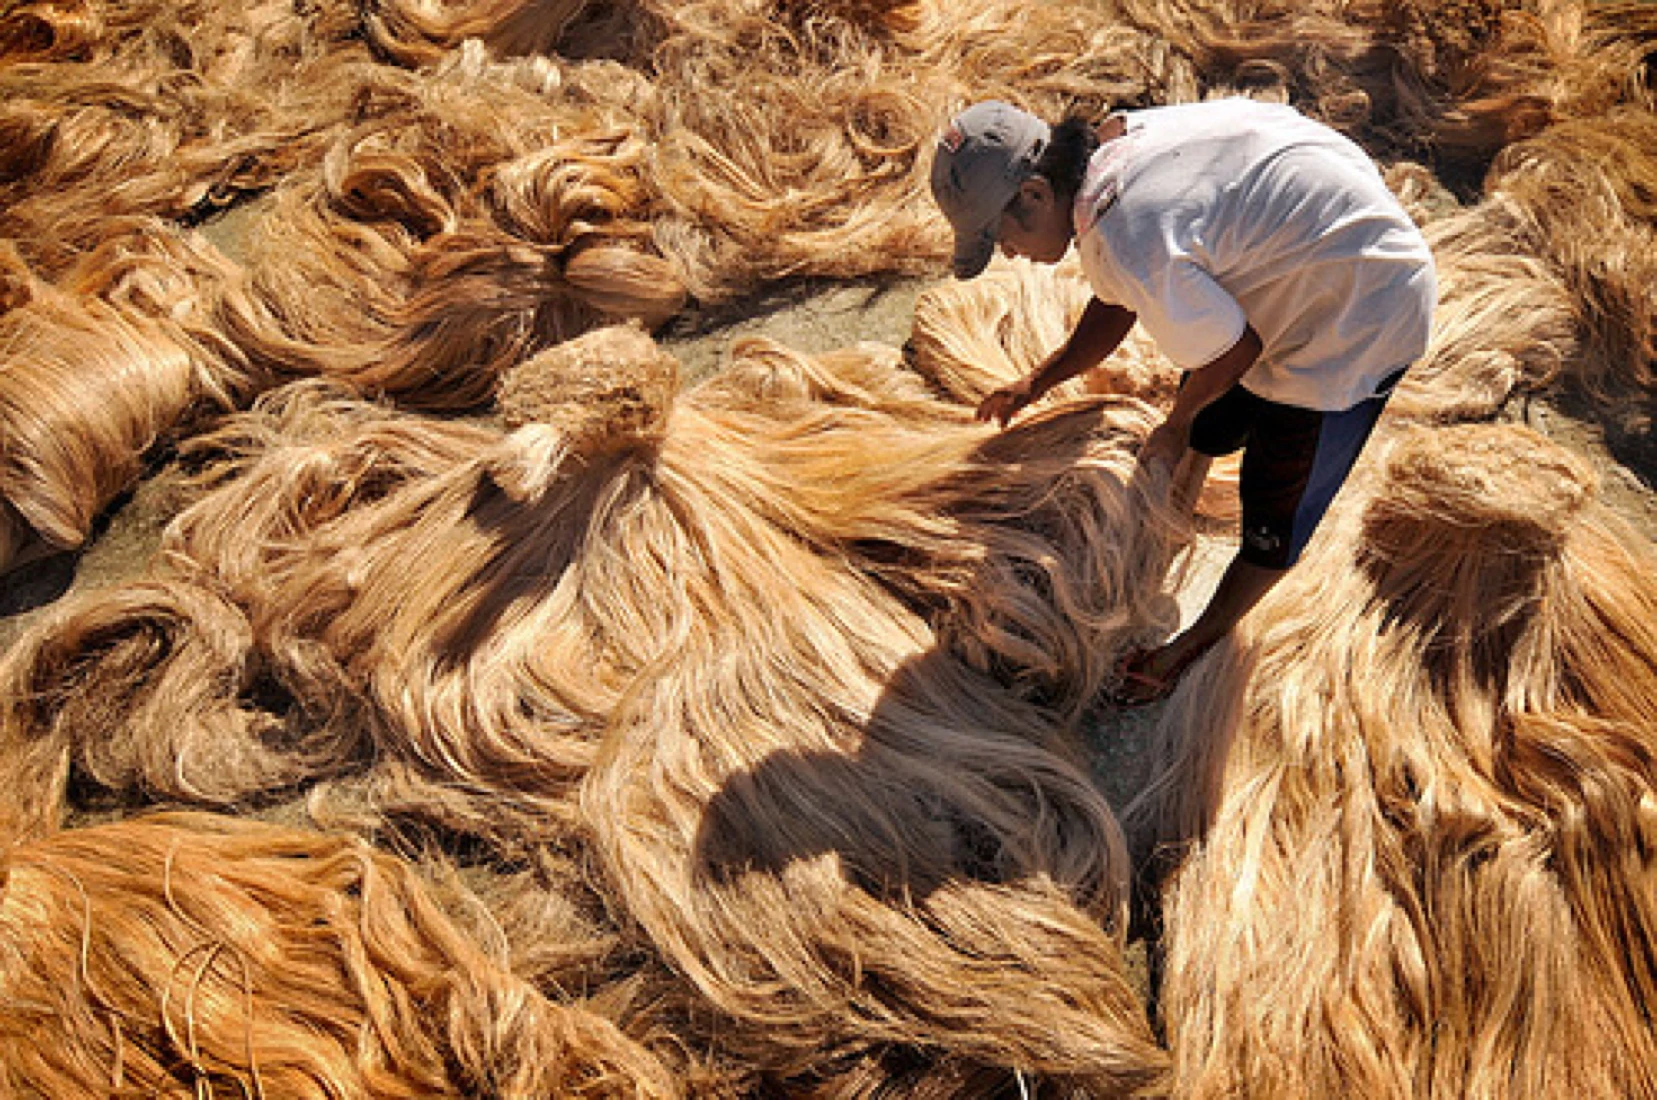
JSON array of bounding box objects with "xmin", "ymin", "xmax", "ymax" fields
[{"xmin": 1191, "ymin": 371, "xmax": 1403, "ymax": 570}]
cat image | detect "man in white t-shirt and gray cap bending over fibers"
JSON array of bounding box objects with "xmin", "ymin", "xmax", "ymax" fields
[{"xmin": 931, "ymin": 99, "xmax": 1437, "ymax": 704}]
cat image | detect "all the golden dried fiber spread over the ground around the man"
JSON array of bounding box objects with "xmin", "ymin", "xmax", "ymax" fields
[{"xmin": 0, "ymin": 0, "xmax": 1657, "ymax": 1097}]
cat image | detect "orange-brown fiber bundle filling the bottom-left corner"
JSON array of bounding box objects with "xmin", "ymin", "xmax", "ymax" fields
[{"xmin": 0, "ymin": 815, "xmax": 679, "ymax": 1098}]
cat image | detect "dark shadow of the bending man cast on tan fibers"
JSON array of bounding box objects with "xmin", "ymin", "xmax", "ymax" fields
[{"xmin": 693, "ymin": 398, "xmax": 1193, "ymax": 906}]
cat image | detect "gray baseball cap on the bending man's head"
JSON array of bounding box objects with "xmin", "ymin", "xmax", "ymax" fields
[{"xmin": 931, "ymin": 99, "xmax": 1051, "ymax": 278}]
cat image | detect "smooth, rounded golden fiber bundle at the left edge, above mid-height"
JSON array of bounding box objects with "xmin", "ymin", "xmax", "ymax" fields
[{"xmin": 0, "ymin": 219, "xmax": 305, "ymax": 570}]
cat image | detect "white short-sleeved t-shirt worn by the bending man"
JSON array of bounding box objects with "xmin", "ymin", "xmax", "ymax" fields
[{"xmin": 1074, "ymin": 99, "xmax": 1437, "ymax": 411}]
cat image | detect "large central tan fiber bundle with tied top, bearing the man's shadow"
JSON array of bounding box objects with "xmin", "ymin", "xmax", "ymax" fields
[{"xmin": 15, "ymin": 313, "xmax": 1176, "ymax": 1090}]
